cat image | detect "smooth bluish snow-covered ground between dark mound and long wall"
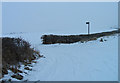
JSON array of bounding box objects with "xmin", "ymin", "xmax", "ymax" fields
[{"xmin": 3, "ymin": 33, "xmax": 118, "ymax": 81}]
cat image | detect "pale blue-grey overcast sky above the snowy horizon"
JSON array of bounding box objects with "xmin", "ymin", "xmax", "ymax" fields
[{"xmin": 2, "ymin": 2, "xmax": 118, "ymax": 33}]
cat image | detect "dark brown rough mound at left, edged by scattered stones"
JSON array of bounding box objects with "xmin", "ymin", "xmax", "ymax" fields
[{"xmin": 2, "ymin": 37, "xmax": 43, "ymax": 80}]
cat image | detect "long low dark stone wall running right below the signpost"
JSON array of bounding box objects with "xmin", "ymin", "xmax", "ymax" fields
[{"xmin": 41, "ymin": 29, "xmax": 120, "ymax": 44}]
